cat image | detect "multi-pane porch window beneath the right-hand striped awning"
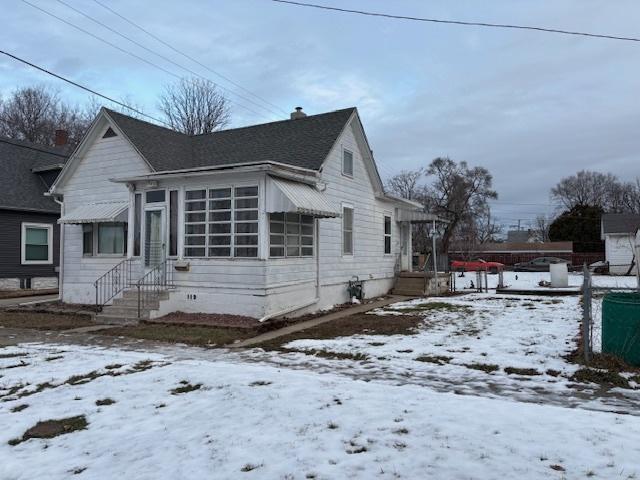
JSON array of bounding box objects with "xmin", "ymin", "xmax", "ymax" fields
[{"xmin": 269, "ymin": 213, "xmax": 313, "ymax": 257}]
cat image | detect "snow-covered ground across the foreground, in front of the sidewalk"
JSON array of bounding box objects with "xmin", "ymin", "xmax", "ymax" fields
[{"xmin": 0, "ymin": 344, "xmax": 640, "ymax": 480}]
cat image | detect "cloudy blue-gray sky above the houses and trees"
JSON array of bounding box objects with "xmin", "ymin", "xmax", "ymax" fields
[{"xmin": 0, "ymin": 0, "xmax": 640, "ymax": 229}]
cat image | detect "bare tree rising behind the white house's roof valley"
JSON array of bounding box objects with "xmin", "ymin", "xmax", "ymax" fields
[{"xmin": 159, "ymin": 78, "xmax": 231, "ymax": 135}]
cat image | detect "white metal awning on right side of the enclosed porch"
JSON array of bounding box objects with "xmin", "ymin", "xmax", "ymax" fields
[{"xmin": 267, "ymin": 177, "xmax": 340, "ymax": 218}]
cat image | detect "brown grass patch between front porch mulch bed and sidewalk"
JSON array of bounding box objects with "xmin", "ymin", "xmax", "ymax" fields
[{"xmin": 98, "ymin": 323, "xmax": 258, "ymax": 347}]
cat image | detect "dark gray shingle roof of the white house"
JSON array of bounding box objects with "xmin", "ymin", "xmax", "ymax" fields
[{"xmin": 106, "ymin": 108, "xmax": 356, "ymax": 172}]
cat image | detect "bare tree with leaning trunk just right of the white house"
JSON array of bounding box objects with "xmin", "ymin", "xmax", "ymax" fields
[{"xmin": 425, "ymin": 157, "xmax": 498, "ymax": 252}]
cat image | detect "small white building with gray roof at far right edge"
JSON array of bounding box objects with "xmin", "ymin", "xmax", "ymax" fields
[{"xmin": 601, "ymin": 213, "xmax": 640, "ymax": 275}]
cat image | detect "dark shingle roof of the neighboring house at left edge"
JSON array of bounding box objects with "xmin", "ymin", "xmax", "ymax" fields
[{"xmin": 0, "ymin": 137, "xmax": 68, "ymax": 212}]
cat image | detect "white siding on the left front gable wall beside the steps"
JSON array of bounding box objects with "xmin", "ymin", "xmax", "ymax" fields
[{"xmin": 62, "ymin": 125, "xmax": 150, "ymax": 303}]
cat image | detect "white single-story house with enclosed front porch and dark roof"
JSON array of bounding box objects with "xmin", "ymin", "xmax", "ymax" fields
[{"xmin": 50, "ymin": 108, "xmax": 435, "ymax": 318}]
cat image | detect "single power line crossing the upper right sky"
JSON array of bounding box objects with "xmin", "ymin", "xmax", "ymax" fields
[{"xmin": 271, "ymin": 0, "xmax": 640, "ymax": 42}]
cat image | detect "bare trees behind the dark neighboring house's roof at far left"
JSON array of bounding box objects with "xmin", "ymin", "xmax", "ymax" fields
[{"xmin": 0, "ymin": 85, "xmax": 89, "ymax": 145}]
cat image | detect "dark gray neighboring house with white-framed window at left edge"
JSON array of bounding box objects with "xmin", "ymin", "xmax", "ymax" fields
[{"xmin": 0, "ymin": 135, "xmax": 68, "ymax": 290}]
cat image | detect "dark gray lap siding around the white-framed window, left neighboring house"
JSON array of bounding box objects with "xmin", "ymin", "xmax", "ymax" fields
[{"xmin": 0, "ymin": 210, "xmax": 60, "ymax": 278}]
